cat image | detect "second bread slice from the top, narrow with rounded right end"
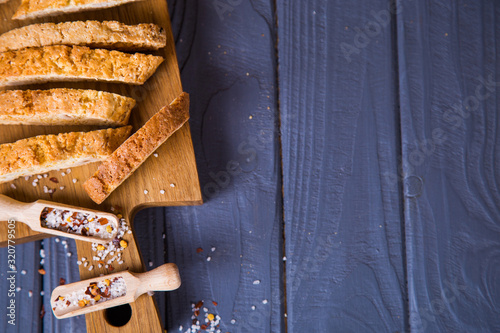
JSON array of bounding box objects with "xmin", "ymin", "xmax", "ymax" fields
[{"xmin": 0, "ymin": 20, "xmax": 167, "ymax": 52}]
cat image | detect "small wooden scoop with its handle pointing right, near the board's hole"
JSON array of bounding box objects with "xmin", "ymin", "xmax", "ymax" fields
[{"xmin": 50, "ymin": 264, "xmax": 181, "ymax": 319}]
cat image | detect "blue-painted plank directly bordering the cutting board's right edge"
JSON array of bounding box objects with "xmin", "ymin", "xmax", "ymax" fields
[{"xmin": 135, "ymin": 0, "xmax": 284, "ymax": 333}]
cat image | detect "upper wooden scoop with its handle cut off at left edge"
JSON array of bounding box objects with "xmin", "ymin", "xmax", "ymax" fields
[{"xmin": 0, "ymin": 194, "xmax": 119, "ymax": 244}]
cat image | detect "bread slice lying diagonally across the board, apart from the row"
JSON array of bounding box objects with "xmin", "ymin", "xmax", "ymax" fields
[{"xmin": 83, "ymin": 93, "xmax": 189, "ymax": 204}]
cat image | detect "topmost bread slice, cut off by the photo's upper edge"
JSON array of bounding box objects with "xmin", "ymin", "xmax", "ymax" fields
[{"xmin": 12, "ymin": 0, "xmax": 145, "ymax": 20}]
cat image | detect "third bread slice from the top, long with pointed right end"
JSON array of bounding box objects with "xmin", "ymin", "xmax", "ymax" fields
[{"xmin": 0, "ymin": 45, "xmax": 163, "ymax": 86}]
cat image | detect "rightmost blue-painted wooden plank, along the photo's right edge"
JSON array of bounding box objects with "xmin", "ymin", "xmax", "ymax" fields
[{"xmin": 398, "ymin": 0, "xmax": 500, "ymax": 332}]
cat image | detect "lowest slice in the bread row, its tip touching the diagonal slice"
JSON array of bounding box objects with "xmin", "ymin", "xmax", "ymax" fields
[{"xmin": 0, "ymin": 126, "xmax": 132, "ymax": 183}]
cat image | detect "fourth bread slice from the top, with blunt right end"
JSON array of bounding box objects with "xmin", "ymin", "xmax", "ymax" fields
[{"xmin": 0, "ymin": 89, "xmax": 136, "ymax": 126}]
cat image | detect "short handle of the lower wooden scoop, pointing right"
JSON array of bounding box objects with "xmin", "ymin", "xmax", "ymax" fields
[{"xmin": 135, "ymin": 263, "xmax": 181, "ymax": 297}]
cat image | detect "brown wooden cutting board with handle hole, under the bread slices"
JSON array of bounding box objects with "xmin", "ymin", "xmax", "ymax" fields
[{"xmin": 0, "ymin": 0, "xmax": 202, "ymax": 333}]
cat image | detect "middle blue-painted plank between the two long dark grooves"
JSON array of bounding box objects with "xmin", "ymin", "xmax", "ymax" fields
[{"xmin": 277, "ymin": 1, "xmax": 406, "ymax": 333}]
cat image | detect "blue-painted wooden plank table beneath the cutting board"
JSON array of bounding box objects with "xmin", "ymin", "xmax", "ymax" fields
[{"xmin": 0, "ymin": 0, "xmax": 500, "ymax": 333}]
